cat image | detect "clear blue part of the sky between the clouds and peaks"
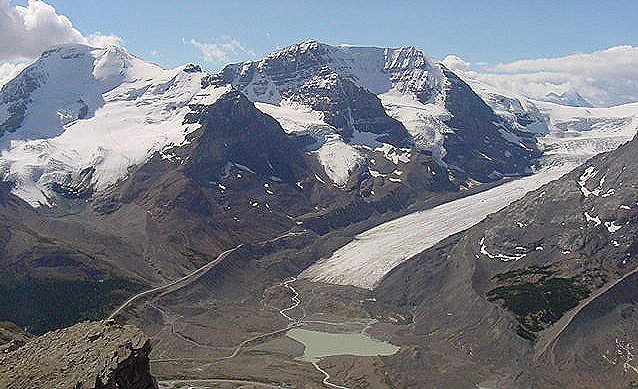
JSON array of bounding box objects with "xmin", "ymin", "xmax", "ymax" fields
[{"xmin": 23, "ymin": 0, "xmax": 638, "ymax": 70}]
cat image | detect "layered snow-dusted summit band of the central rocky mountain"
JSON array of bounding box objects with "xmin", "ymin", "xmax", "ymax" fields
[{"xmin": 223, "ymin": 40, "xmax": 442, "ymax": 103}]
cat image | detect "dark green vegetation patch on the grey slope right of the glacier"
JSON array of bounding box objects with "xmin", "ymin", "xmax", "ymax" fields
[{"xmin": 487, "ymin": 266, "xmax": 590, "ymax": 340}]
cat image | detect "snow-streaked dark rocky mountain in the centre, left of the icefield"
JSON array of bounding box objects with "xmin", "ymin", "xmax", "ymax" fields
[{"xmin": 220, "ymin": 41, "xmax": 540, "ymax": 189}]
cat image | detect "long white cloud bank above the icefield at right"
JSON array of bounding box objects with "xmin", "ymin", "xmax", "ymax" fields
[{"xmin": 452, "ymin": 46, "xmax": 638, "ymax": 107}]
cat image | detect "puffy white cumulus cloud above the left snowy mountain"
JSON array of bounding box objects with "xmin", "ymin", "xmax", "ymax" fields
[{"xmin": 0, "ymin": 0, "xmax": 121, "ymax": 62}]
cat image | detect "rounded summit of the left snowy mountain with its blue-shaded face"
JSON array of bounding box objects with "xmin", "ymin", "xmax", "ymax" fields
[{"xmin": 0, "ymin": 44, "xmax": 165, "ymax": 144}]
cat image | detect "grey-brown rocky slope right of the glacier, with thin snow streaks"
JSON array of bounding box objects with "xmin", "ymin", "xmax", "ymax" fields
[{"xmin": 375, "ymin": 133, "xmax": 638, "ymax": 388}]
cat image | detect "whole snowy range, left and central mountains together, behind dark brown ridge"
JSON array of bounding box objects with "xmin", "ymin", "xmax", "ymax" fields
[{"xmin": 0, "ymin": 41, "xmax": 627, "ymax": 212}]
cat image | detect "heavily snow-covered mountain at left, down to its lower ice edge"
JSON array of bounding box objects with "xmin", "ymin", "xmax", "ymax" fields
[{"xmin": 0, "ymin": 45, "xmax": 228, "ymax": 205}]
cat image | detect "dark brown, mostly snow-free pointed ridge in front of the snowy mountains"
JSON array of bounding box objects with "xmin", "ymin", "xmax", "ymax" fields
[{"xmin": 92, "ymin": 91, "xmax": 318, "ymax": 270}]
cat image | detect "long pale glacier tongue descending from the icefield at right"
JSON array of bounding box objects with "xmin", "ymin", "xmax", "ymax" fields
[{"xmin": 299, "ymin": 103, "xmax": 638, "ymax": 289}]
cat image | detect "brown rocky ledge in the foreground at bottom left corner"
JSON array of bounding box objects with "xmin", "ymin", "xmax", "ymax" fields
[{"xmin": 0, "ymin": 320, "xmax": 157, "ymax": 389}]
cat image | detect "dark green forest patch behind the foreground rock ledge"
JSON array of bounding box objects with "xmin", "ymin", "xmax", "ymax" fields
[{"xmin": 0, "ymin": 278, "xmax": 142, "ymax": 335}]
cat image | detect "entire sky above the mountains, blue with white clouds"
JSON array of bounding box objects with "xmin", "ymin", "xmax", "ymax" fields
[{"xmin": 0, "ymin": 0, "xmax": 638, "ymax": 106}]
